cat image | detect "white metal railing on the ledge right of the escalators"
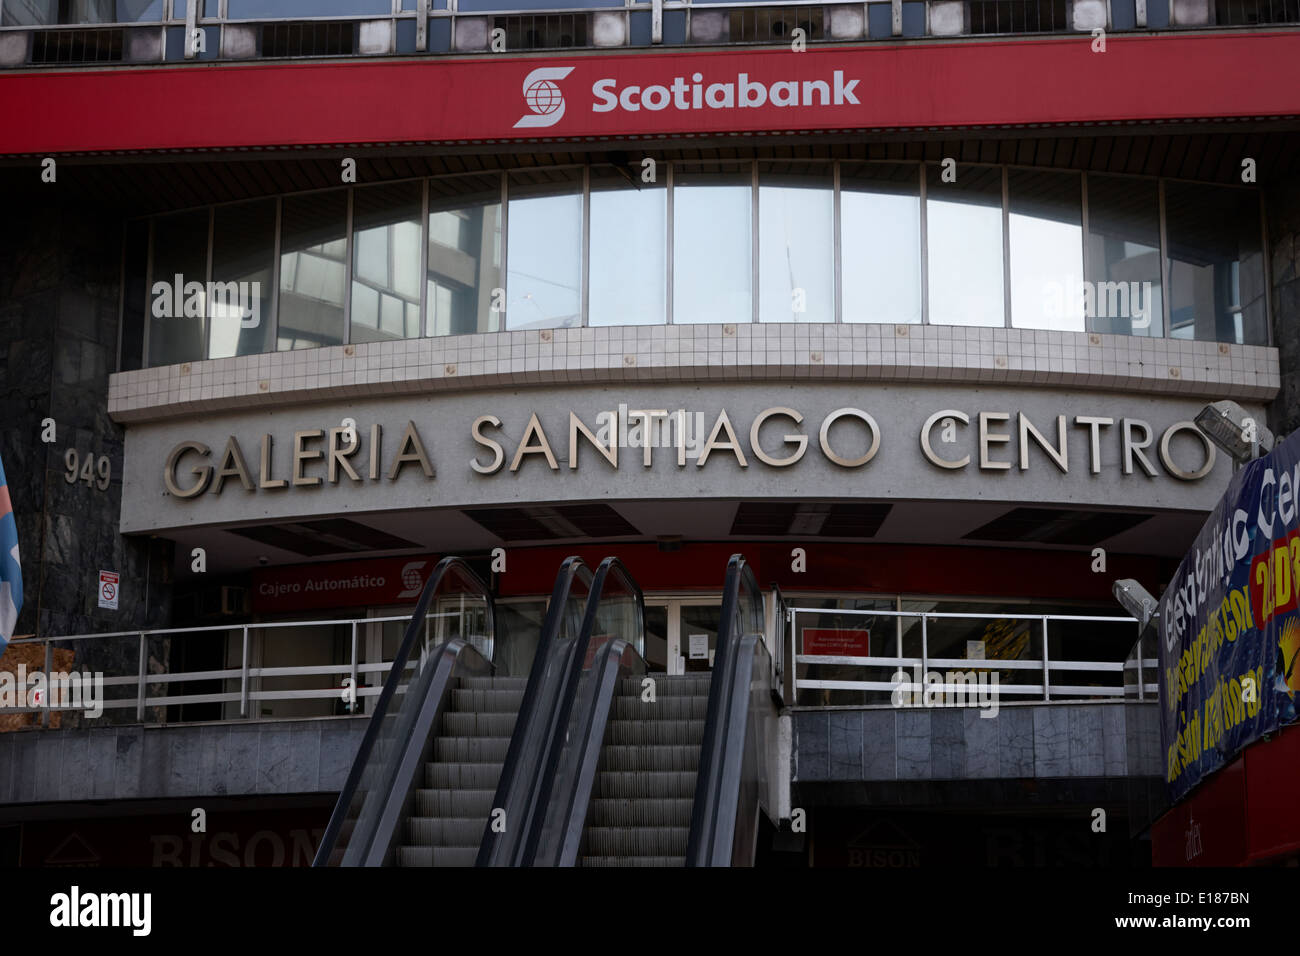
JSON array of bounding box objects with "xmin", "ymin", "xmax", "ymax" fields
[{"xmin": 781, "ymin": 606, "xmax": 1158, "ymax": 706}]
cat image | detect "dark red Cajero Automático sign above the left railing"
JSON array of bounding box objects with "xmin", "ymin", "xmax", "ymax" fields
[{"xmin": 252, "ymin": 555, "xmax": 438, "ymax": 614}]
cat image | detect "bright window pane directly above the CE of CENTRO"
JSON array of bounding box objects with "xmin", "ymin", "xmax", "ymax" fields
[{"xmin": 926, "ymin": 165, "xmax": 1005, "ymax": 326}]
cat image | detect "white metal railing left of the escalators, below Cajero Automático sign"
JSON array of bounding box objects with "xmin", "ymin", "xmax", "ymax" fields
[{"xmin": 0, "ymin": 607, "xmax": 493, "ymax": 727}]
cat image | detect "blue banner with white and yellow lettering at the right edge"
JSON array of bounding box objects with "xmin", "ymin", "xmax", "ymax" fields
[{"xmin": 1160, "ymin": 432, "xmax": 1300, "ymax": 800}]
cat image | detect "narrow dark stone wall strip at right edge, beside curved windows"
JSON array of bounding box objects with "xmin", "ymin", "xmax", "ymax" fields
[{"xmin": 1265, "ymin": 183, "xmax": 1300, "ymax": 437}]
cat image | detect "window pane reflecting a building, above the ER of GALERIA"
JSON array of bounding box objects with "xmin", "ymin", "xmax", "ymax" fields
[{"xmin": 277, "ymin": 190, "xmax": 347, "ymax": 351}]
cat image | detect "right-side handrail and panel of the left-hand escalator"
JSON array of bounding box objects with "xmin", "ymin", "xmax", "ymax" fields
[{"xmin": 475, "ymin": 555, "xmax": 594, "ymax": 866}]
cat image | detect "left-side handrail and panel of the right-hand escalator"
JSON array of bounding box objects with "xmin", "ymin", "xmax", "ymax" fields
[{"xmin": 523, "ymin": 557, "xmax": 645, "ymax": 866}]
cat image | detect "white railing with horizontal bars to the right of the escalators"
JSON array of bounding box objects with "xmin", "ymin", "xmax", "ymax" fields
[{"xmin": 781, "ymin": 606, "xmax": 1158, "ymax": 706}]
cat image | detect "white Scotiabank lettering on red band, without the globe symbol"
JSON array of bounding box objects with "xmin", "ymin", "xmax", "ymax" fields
[{"xmin": 592, "ymin": 70, "xmax": 858, "ymax": 113}]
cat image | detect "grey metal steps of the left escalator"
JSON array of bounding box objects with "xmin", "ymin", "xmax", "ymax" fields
[{"xmin": 397, "ymin": 678, "xmax": 528, "ymax": 866}]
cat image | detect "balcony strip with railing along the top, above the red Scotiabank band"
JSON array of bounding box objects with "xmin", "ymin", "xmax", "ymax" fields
[{"xmin": 0, "ymin": 0, "xmax": 1300, "ymax": 69}]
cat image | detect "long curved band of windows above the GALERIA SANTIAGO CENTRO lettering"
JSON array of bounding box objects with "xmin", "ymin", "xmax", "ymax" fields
[{"xmin": 122, "ymin": 156, "xmax": 1270, "ymax": 369}]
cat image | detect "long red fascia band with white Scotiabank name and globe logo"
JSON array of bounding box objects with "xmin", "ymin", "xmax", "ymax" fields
[{"xmin": 0, "ymin": 33, "xmax": 1300, "ymax": 155}]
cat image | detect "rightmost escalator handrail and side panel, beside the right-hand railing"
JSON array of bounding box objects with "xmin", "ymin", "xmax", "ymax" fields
[{"xmin": 686, "ymin": 554, "xmax": 766, "ymax": 866}]
